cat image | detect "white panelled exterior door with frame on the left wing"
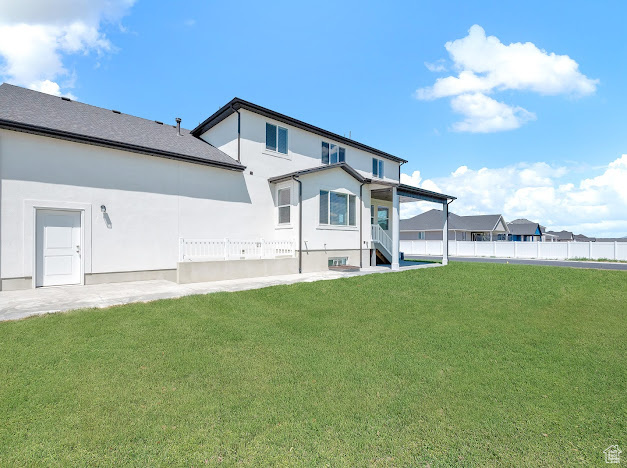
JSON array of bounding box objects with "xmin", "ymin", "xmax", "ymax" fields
[{"xmin": 35, "ymin": 210, "xmax": 82, "ymax": 286}]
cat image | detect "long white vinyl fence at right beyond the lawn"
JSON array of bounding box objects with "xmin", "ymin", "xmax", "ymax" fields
[{"xmin": 401, "ymin": 240, "xmax": 627, "ymax": 261}]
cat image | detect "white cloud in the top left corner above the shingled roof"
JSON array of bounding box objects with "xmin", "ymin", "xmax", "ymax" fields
[{"xmin": 0, "ymin": 0, "xmax": 135, "ymax": 95}]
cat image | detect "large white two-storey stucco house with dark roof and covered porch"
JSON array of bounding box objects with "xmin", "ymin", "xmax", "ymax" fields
[{"xmin": 0, "ymin": 84, "xmax": 454, "ymax": 290}]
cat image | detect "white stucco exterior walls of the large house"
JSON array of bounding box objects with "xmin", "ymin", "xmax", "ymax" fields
[{"xmin": 0, "ymin": 106, "xmax": 398, "ymax": 286}]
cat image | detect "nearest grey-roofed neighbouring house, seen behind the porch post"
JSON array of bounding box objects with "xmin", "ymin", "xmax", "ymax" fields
[{"xmin": 401, "ymin": 209, "xmax": 508, "ymax": 241}]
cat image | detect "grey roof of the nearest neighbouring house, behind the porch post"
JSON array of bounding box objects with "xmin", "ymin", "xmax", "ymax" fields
[{"xmin": 400, "ymin": 209, "xmax": 505, "ymax": 232}]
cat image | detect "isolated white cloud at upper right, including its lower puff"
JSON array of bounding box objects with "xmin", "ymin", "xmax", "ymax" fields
[{"xmin": 416, "ymin": 25, "xmax": 599, "ymax": 132}]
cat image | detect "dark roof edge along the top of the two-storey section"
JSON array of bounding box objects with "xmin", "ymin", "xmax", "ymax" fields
[{"xmin": 191, "ymin": 98, "xmax": 407, "ymax": 163}]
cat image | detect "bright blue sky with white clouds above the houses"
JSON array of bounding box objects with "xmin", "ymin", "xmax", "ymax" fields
[{"xmin": 0, "ymin": 0, "xmax": 627, "ymax": 236}]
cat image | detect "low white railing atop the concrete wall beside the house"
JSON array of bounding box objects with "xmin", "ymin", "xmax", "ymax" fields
[{"xmin": 179, "ymin": 238, "xmax": 295, "ymax": 262}]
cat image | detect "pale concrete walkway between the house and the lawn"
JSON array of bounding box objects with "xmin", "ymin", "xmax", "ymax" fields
[{"xmin": 0, "ymin": 262, "xmax": 442, "ymax": 321}]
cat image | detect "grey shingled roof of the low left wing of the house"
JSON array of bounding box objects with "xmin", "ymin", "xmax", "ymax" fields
[{"xmin": 0, "ymin": 83, "xmax": 245, "ymax": 171}]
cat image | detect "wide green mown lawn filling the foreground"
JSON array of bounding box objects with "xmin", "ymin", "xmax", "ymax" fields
[{"xmin": 0, "ymin": 263, "xmax": 627, "ymax": 467}]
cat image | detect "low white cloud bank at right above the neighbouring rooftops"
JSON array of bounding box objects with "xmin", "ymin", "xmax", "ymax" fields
[{"xmin": 401, "ymin": 154, "xmax": 627, "ymax": 237}]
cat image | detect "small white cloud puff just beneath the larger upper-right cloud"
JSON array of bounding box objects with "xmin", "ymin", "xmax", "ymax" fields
[{"xmin": 451, "ymin": 93, "xmax": 536, "ymax": 133}]
